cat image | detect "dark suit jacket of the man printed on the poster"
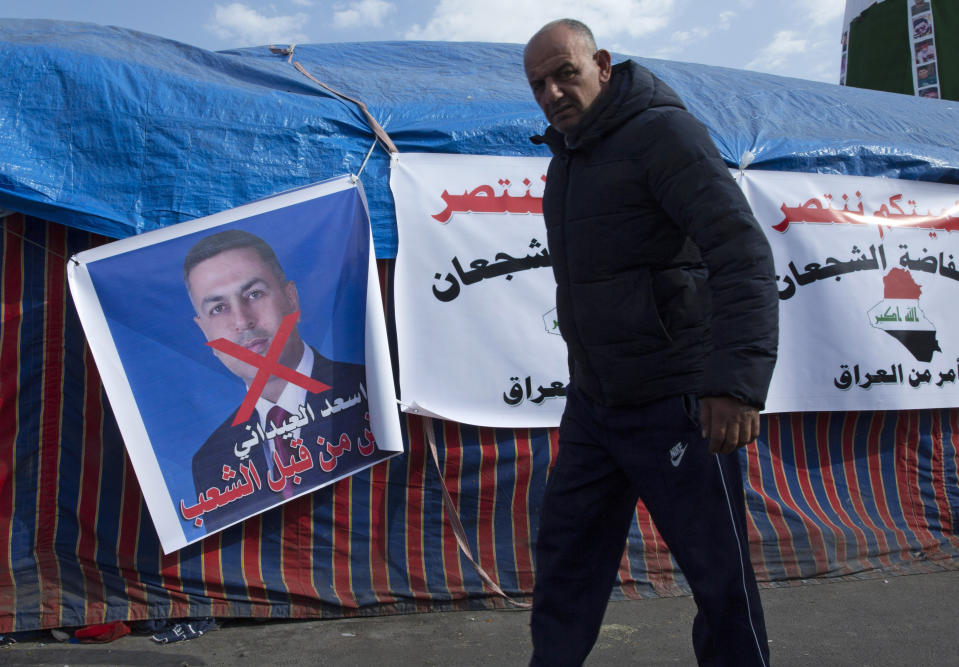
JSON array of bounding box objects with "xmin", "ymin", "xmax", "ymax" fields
[{"xmin": 189, "ymin": 350, "xmax": 389, "ymax": 532}]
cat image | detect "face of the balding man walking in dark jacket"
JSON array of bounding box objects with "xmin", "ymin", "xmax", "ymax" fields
[{"xmin": 523, "ymin": 25, "xmax": 611, "ymax": 134}]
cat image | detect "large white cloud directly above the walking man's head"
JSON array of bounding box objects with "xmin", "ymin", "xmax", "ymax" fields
[{"xmin": 406, "ymin": 0, "xmax": 676, "ymax": 44}]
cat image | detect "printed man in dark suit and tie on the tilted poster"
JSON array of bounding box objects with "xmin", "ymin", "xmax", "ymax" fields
[{"xmin": 181, "ymin": 229, "xmax": 385, "ymax": 532}]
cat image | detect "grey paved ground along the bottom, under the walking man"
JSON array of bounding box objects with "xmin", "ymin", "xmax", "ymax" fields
[{"xmin": 7, "ymin": 572, "xmax": 959, "ymax": 667}]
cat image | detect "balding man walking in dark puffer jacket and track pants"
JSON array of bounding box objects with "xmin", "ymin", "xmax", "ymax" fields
[{"xmin": 524, "ymin": 19, "xmax": 778, "ymax": 666}]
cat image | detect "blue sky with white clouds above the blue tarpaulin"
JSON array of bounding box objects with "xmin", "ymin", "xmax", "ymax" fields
[{"xmin": 0, "ymin": 0, "xmax": 845, "ymax": 83}]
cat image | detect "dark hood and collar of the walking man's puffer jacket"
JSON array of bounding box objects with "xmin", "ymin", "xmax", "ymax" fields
[{"xmin": 530, "ymin": 60, "xmax": 686, "ymax": 154}]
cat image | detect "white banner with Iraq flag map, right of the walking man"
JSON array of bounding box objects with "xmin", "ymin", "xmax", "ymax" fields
[{"xmin": 743, "ymin": 171, "xmax": 959, "ymax": 412}]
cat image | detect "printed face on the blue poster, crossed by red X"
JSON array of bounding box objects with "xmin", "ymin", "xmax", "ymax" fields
[{"xmin": 188, "ymin": 248, "xmax": 302, "ymax": 386}]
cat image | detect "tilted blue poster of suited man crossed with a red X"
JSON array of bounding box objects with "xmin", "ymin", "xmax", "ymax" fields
[{"xmin": 68, "ymin": 177, "xmax": 402, "ymax": 553}]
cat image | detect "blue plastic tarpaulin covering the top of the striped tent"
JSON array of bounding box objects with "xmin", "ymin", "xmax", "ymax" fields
[{"xmin": 0, "ymin": 20, "xmax": 959, "ymax": 258}]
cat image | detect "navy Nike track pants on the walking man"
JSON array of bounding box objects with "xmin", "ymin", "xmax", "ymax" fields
[{"xmin": 530, "ymin": 386, "xmax": 769, "ymax": 667}]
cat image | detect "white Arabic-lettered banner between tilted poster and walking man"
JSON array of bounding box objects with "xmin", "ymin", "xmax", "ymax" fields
[{"xmin": 390, "ymin": 154, "xmax": 569, "ymax": 427}]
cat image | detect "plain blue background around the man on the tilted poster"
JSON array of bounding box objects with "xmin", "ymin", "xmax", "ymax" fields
[{"xmin": 88, "ymin": 188, "xmax": 369, "ymax": 540}]
